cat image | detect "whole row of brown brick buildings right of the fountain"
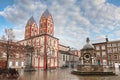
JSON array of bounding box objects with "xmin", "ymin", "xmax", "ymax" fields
[{"xmin": 93, "ymin": 40, "xmax": 120, "ymax": 68}]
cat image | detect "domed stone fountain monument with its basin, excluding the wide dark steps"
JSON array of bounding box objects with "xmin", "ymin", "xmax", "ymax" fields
[{"xmin": 77, "ymin": 38, "xmax": 103, "ymax": 72}]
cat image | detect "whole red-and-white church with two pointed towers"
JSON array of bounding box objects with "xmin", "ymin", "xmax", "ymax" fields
[{"xmin": 18, "ymin": 9, "xmax": 59, "ymax": 69}]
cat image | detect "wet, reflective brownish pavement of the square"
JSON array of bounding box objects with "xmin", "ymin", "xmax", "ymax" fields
[{"xmin": 1, "ymin": 69, "xmax": 120, "ymax": 80}]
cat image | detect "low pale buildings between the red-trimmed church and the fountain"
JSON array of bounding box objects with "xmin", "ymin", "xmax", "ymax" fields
[{"xmin": 59, "ymin": 45, "xmax": 80, "ymax": 68}]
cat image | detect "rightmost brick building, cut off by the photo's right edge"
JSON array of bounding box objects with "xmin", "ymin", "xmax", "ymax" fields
[{"xmin": 107, "ymin": 40, "xmax": 120, "ymax": 67}]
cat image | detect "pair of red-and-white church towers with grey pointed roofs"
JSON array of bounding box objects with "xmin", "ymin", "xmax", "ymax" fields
[{"xmin": 25, "ymin": 9, "xmax": 54, "ymax": 39}]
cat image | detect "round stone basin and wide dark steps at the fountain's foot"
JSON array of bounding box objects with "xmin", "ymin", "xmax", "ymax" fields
[{"xmin": 71, "ymin": 65, "xmax": 116, "ymax": 76}]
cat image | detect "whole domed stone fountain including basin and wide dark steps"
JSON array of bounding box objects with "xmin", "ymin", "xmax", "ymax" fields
[{"xmin": 72, "ymin": 38, "xmax": 115, "ymax": 75}]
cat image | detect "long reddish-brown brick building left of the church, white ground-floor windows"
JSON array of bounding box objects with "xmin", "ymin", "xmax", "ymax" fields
[{"xmin": 0, "ymin": 40, "xmax": 26, "ymax": 68}]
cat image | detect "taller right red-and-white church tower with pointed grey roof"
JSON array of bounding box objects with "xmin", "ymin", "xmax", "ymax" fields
[{"xmin": 39, "ymin": 9, "xmax": 54, "ymax": 36}]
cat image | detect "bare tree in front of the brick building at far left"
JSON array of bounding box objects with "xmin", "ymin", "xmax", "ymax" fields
[{"xmin": 0, "ymin": 29, "xmax": 26, "ymax": 68}]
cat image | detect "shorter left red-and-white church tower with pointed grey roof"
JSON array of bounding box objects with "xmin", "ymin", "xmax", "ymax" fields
[{"xmin": 25, "ymin": 16, "xmax": 38, "ymax": 39}]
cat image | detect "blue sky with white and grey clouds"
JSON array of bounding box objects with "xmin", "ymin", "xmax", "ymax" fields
[{"xmin": 0, "ymin": 0, "xmax": 120, "ymax": 49}]
